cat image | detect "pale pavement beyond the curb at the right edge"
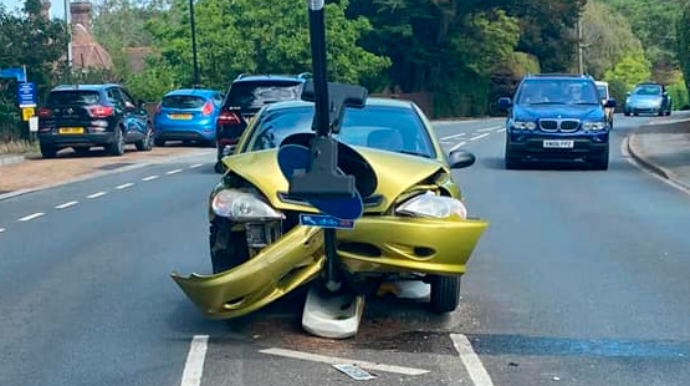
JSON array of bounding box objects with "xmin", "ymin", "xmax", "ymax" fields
[{"xmin": 628, "ymin": 112, "xmax": 690, "ymax": 189}]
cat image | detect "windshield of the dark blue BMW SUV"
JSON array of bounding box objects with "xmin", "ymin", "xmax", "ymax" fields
[{"xmin": 516, "ymin": 79, "xmax": 601, "ymax": 105}]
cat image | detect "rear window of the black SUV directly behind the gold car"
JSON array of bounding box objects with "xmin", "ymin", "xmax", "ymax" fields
[{"xmin": 226, "ymin": 81, "xmax": 302, "ymax": 108}]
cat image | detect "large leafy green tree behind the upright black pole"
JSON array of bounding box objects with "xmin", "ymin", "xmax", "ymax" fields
[{"xmin": 146, "ymin": 0, "xmax": 389, "ymax": 88}]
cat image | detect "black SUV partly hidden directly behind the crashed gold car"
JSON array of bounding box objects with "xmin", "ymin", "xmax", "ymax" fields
[{"xmin": 215, "ymin": 73, "xmax": 311, "ymax": 173}]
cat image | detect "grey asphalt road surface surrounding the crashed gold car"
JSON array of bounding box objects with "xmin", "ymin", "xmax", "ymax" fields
[{"xmin": 0, "ymin": 117, "xmax": 690, "ymax": 386}]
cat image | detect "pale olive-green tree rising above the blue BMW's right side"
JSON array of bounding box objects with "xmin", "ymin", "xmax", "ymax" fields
[{"xmin": 582, "ymin": 2, "xmax": 643, "ymax": 79}]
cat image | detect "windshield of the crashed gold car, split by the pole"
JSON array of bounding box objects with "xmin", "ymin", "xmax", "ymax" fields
[{"xmin": 246, "ymin": 106, "xmax": 435, "ymax": 158}]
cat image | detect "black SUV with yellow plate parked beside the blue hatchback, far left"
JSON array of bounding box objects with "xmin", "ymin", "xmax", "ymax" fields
[{"xmin": 38, "ymin": 84, "xmax": 153, "ymax": 158}]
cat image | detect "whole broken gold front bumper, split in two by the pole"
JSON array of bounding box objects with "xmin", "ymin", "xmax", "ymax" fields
[{"xmin": 172, "ymin": 216, "xmax": 487, "ymax": 319}]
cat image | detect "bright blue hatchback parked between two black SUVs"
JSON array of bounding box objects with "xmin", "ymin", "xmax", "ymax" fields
[{"xmin": 153, "ymin": 89, "xmax": 224, "ymax": 146}]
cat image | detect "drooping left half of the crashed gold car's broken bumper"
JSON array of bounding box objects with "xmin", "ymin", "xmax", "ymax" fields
[{"xmin": 172, "ymin": 226, "xmax": 325, "ymax": 319}]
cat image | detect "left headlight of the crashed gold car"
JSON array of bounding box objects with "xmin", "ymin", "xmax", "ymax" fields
[{"xmin": 211, "ymin": 189, "xmax": 285, "ymax": 222}]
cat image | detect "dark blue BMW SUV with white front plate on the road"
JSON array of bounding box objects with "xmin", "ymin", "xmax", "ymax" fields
[{"xmin": 499, "ymin": 75, "xmax": 616, "ymax": 170}]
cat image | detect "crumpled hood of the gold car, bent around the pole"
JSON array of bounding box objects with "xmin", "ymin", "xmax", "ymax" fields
[{"xmin": 223, "ymin": 147, "xmax": 448, "ymax": 212}]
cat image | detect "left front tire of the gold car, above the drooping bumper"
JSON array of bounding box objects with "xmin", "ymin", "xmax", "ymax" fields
[{"xmin": 209, "ymin": 218, "xmax": 249, "ymax": 274}]
